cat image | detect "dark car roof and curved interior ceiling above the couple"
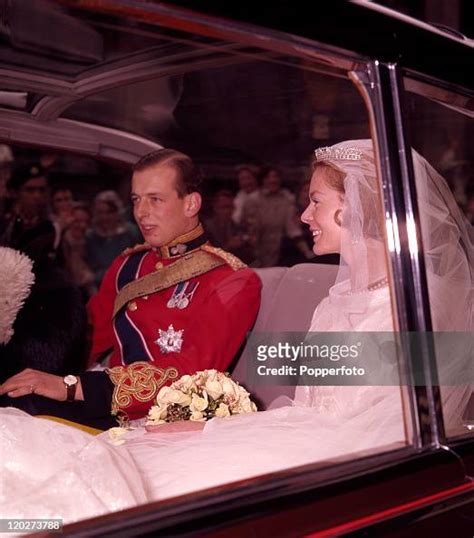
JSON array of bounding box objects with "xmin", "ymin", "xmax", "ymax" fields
[{"xmin": 0, "ymin": 0, "xmax": 473, "ymax": 162}]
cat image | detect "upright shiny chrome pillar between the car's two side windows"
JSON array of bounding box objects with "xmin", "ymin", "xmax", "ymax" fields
[{"xmin": 353, "ymin": 61, "xmax": 444, "ymax": 448}]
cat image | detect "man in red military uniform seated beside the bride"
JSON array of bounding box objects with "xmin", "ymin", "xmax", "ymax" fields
[{"xmin": 0, "ymin": 149, "xmax": 261, "ymax": 428}]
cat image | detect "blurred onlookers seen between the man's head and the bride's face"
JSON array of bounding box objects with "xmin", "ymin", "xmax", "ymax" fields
[{"xmin": 204, "ymin": 161, "xmax": 328, "ymax": 267}]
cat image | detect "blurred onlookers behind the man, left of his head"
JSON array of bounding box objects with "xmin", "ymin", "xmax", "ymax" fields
[{"xmin": 0, "ymin": 146, "xmax": 141, "ymax": 299}]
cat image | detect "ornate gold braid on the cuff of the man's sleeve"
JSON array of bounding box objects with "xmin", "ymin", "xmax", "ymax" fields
[{"xmin": 107, "ymin": 361, "xmax": 178, "ymax": 415}]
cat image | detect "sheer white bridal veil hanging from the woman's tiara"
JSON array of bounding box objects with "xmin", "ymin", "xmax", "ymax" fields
[{"xmin": 296, "ymin": 140, "xmax": 474, "ymax": 433}]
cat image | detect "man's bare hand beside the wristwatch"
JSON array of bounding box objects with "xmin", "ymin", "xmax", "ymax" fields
[{"xmin": 0, "ymin": 368, "xmax": 84, "ymax": 401}]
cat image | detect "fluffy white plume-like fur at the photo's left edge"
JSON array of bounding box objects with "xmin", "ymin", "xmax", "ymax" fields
[{"xmin": 0, "ymin": 247, "xmax": 35, "ymax": 344}]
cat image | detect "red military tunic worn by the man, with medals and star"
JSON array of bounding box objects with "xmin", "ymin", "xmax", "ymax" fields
[{"xmin": 86, "ymin": 229, "xmax": 261, "ymax": 419}]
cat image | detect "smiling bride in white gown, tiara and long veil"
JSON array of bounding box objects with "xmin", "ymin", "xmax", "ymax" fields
[{"xmin": 0, "ymin": 140, "xmax": 473, "ymax": 522}]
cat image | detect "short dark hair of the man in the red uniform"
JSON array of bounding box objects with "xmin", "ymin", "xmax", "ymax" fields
[{"xmin": 133, "ymin": 149, "xmax": 202, "ymax": 198}]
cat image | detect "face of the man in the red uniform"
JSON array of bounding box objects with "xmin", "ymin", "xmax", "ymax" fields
[{"xmin": 131, "ymin": 164, "xmax": 200, "ymax": 247}]
